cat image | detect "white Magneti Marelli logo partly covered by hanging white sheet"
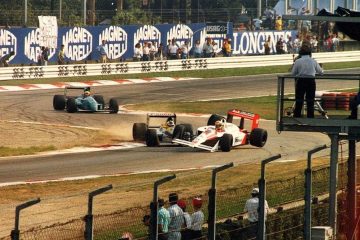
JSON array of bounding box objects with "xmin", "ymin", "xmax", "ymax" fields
[{"xmin": 24, "ymin": 28, "xmax": 56, "ymax": 62}]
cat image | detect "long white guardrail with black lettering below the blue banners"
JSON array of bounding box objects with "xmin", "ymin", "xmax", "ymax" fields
[{"xmin": 0, "ymin": 51, "xmax": 360, "ymax": 80}]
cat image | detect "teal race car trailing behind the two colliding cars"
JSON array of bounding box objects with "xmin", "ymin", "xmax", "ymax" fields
[{"xmin": 53, "ymin": 86, "xmax": 119, "ymax": 113}]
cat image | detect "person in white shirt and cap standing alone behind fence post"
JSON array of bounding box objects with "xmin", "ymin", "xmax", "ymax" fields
[{"xmin": 244, "ymin": 188, "xmax": 269, "ymax": 238}]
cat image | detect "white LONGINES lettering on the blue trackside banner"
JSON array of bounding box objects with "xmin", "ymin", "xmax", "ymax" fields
[{"xmin": 233, "ymin": 31, "xmax": 295, "ymax": 55}]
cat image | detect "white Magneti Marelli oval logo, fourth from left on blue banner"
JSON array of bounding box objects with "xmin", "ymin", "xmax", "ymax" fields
[{"xmin": 99, "ymin": 26, "xmax": 128, "ymax": 59}]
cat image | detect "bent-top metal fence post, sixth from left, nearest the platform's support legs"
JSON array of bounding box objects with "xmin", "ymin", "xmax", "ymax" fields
[{"xmin": 304, "ymin": 145, "xmax": 327, "ymax": 240}]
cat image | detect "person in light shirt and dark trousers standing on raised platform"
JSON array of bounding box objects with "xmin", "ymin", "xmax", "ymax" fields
[{"xmin": 292, "ymin": 42, "xmax": 324, "ymax": 118}]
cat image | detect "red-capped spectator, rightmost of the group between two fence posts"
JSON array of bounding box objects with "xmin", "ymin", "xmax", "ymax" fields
[{"xmin": 191, "ymin": 197, "xmax": 204, "ymax": 239}]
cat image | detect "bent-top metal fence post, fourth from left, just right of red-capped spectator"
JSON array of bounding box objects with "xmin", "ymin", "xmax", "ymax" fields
[{"xmin": 208, "ymin": 163, "xmax": 234, "ymax": 240}]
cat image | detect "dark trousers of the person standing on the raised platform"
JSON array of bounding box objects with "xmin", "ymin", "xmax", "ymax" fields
[{"xmin": 294, "ymin": 78, "xmax": 316, "ymax": 118}]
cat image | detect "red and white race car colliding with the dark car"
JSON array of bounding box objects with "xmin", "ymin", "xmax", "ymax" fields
[{"xmin": 173, "ymin": 109, "xmax": 267, "ymax": 152}]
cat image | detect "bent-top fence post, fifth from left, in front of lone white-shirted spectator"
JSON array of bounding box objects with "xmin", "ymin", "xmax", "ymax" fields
[{"xmin": 256, "ymin": 154, "xmax": 281, "ymax": 240}]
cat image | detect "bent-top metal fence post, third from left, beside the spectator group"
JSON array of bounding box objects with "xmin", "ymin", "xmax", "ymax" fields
[{"xmin": 150, "ymin": 174, "xmax": 176, "ymax": 240}]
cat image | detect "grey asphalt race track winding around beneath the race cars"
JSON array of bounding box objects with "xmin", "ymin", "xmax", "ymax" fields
[{"xmin": 0, "ymin": 70, "xmax": 360, "ymax": 183}]
